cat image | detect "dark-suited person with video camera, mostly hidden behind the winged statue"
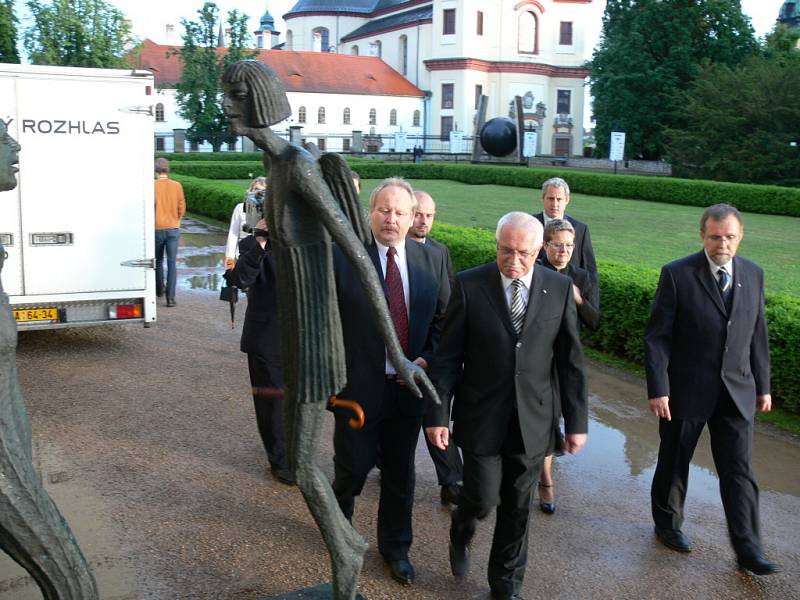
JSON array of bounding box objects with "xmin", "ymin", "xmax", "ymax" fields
[{"xmin": 225, "ymin": 219, "xmax": 294, "ymax": 485}]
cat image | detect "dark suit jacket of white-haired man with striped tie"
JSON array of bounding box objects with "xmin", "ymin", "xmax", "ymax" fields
[{"xmin": 425, "ymin": 263, "xmax": 588, "ymax": 457}]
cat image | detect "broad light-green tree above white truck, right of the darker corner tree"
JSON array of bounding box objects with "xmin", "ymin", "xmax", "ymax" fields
[{"xmin": 25, "ymin": 0, "xmax": 131, "ymax": 68}]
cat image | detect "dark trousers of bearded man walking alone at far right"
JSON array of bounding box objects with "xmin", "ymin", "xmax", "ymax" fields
[{"xmin": 650, "ymin": 388, "xmax": 762, "ymax": 558}]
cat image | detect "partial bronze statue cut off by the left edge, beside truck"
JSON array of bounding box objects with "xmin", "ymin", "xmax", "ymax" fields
[{"xmin": 0, "ymin": 120, "xmax": 99, "ymax": 600}]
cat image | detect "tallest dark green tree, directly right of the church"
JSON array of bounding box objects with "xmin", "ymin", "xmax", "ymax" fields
[{"xmin": 589, "ymin": 0, "xmax": 758, "ymax": 160}]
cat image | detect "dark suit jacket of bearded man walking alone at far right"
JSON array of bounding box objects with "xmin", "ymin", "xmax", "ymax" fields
[{"xmin": 645, "ymin": 251, "xmax": 770, "ymax": 419}]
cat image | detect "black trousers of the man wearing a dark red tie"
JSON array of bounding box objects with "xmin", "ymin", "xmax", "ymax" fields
[{"xmin": 333, "ymin": 380, "xmax": 422, "ymax": 560}]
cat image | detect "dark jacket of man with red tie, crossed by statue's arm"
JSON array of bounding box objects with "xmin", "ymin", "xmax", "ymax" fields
[{"xmin": 333, "ymin": 240, "xmax": 450, "ymax": 419}]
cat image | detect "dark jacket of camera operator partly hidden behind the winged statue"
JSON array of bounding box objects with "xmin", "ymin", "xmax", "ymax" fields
[{"xmin": 227, "ymin": 236, "xmax": 283, "ymax": 387}]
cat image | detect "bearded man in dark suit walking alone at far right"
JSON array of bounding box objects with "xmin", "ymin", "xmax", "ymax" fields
[{"xmin": 645, "ymin": 204, "xmax": 778, "ymax": 575}]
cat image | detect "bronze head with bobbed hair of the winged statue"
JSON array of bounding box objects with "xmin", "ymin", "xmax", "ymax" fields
[{"xmin": 222, "ymin": 60, "xmax": 292, "ymax": 132}]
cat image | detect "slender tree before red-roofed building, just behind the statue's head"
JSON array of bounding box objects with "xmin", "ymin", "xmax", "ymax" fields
[{"xmin": 176, "ymin": 2, "xmax": 256, "ymax": 152}]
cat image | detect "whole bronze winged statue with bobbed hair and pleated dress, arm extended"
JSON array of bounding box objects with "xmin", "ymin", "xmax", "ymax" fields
[{"xmin": 222, "ymin": 60, "xmax": 436, "ymax": 600}]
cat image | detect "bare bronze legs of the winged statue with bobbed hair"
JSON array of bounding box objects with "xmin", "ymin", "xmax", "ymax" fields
[{"xmin": 285, "ymin": 398, "xmax": 367, "ymax": 600}]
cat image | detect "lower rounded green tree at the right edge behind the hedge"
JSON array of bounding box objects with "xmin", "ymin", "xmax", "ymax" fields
[{"xmin": 667, "ymin": 38, "xmax": 800, "ymax": 185}]
